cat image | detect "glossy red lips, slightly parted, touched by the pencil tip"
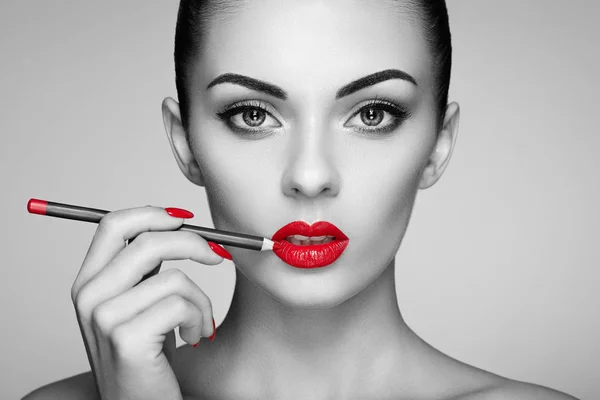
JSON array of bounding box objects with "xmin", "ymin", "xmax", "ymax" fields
[{"xmin": 271, "ymin": 221, "xmax": 349, "ymax": 268}]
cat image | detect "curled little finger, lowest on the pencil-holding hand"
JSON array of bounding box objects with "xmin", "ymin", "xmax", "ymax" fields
[{"xmin": 110, "ymin": 295, "xmax": 203, "ymax": 359}]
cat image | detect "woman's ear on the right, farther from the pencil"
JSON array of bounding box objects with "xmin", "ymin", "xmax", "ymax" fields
[{"xmin": 419, "ymin": 103, "xmax": 460, "ymax": 189}]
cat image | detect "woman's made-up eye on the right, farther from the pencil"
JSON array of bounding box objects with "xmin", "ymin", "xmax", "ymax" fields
[{"xmin": 344, "ymin": 100, "xmax": 410, "ymax": 133}]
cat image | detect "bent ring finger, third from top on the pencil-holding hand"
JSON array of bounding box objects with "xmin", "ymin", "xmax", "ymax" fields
[{"xmin": 92, "ymin": 269, "xmax": 213, "ymax": 337}]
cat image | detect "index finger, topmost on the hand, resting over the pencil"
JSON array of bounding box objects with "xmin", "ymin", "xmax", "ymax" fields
[{"xmin": 71, "ymin": 206, "xmax": 191, "ymax": 299}]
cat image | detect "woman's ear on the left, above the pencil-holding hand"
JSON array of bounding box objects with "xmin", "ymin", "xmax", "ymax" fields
[{"xmin": 162, "ymin": 97, "xmax": 204, "ymax": 186}]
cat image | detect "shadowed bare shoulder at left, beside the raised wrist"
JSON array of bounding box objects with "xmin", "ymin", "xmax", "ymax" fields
[{"xmin": 21, "ymin": 371, "xmax": 99, "ymax": 400}]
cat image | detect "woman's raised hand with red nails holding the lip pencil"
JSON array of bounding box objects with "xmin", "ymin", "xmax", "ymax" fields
[{"xmin": 71, "ymin": 206, "xmax": 223, "ymax": 400}]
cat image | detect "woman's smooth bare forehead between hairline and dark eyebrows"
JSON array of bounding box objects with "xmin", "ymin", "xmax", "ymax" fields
[{"xmin": 198, "ymin": 0, "xmax": 430, "ymax": 92}]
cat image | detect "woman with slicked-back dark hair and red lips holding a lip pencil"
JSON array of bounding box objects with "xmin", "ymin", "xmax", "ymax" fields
[{"xmin": 26, "ymin": 0, "xmax": 572, "ymax": 399}]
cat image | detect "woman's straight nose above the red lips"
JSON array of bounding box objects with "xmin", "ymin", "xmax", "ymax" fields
[{"xmin": 281, "ymin": 124, "xmax": 340, "ymax": 198}]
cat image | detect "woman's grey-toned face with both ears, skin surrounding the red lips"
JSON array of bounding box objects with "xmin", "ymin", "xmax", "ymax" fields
[{"xmin": 166, "ymin": 0, "xmax": 458, "ymax": 307}]
